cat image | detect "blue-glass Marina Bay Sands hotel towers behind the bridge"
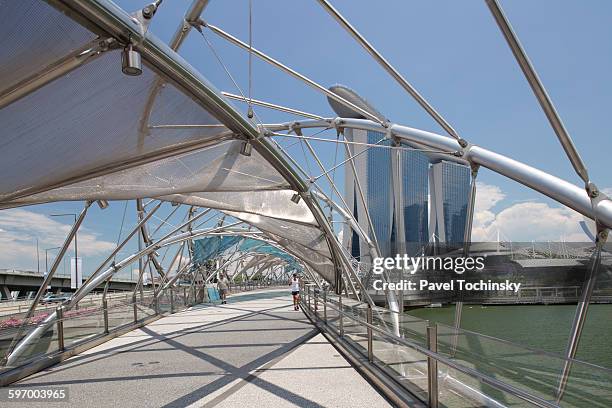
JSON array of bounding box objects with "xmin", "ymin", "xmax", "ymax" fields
[{"xmin": 343, "ymin": 129, "xmax": 470, "ymax": 262}]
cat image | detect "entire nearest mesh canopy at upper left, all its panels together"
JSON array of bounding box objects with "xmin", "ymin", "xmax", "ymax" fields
[{"xmin": 0, "ymin": 0, "xmax": 334, "ymax": 286}]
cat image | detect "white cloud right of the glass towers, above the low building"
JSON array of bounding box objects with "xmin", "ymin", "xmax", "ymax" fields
[{"xmin": 472, "ymin": 183, "xmax": 587, "ymax": 241}]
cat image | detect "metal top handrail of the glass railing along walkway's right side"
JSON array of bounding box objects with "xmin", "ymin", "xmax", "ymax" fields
[{"xmin": 302, "ymin": 288, "xmax": 559, "ymax": 408}]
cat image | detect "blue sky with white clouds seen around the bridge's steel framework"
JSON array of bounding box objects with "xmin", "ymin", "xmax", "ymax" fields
[{"xmin": 0, "ymin": 0, "xmax": 612, "ymax": 271}]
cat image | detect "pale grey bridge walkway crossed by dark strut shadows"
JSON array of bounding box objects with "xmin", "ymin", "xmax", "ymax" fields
[{"xmin": 11, "ymin": 289, "xmax": 389, "ymax": 408}]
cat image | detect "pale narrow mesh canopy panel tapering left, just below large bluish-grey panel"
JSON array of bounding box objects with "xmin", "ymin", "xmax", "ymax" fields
[{"xmin": 7, "ymin": 140, "xmax": 290, "ymax": 206}]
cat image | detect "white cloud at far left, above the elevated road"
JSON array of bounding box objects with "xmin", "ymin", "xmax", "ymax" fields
[{"xmin": 0, "ymin": 208, "xmax": 115, "ymax": 269}]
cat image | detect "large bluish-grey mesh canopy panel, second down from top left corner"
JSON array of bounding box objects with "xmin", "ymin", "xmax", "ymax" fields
[{"xmin": 0, "ymin": 51, "xmax": 231, "ymax": 199}]
